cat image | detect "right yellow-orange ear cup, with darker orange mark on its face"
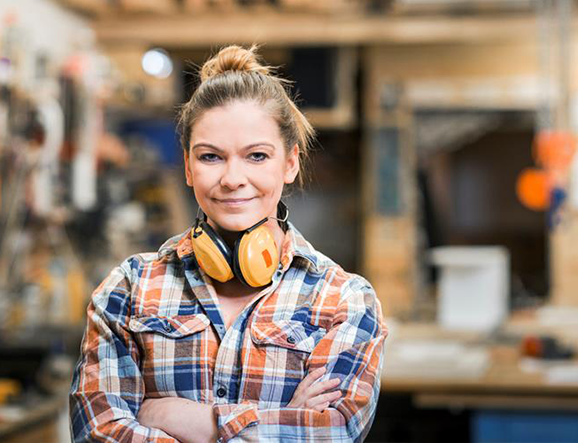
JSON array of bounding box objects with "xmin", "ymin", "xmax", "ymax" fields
[{"xmin": 233, "ymin": 225, "xmax": 279, "ymax": 288}]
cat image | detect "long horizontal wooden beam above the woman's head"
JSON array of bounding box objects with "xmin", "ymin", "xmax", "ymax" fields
[{"xmin": 94, "ymin": 11, "xmax": 537, "ymax": 48}]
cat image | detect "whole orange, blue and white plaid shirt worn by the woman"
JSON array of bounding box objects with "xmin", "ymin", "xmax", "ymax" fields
[{"xmin": 70, "ymin": 223, "xmax": 387, "ymax": 443}]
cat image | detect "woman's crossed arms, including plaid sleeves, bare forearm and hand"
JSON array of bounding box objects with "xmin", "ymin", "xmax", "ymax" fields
[{"xmin": 70, "ymin": 267, "xmax": 386, "ymax": 443}]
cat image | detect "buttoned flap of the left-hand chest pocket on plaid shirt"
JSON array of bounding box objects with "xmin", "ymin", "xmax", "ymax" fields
[{"xmin": 128, "ymin": 314, "xmax": 209, "ymax": 338}]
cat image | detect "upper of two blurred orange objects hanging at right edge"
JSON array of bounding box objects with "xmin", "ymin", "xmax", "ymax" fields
[{"xmin": 534, "ymin": 131, "xmax": 576, "ymax": 170}]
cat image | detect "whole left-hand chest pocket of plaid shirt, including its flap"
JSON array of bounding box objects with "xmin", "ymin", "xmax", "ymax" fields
[{"xmin": 129, "ymin": 314, "xmax": 211, "ymax": 398}]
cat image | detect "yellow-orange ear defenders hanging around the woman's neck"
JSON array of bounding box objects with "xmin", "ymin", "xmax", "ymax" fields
[{"xmin": 191, "ymin": 202, "xmax": 289, "ymax": 288}]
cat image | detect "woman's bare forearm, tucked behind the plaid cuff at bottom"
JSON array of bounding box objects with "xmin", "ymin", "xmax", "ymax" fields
[{"xmin": 137, "ymin": 397, "xmax": 217, "ymax": 443}]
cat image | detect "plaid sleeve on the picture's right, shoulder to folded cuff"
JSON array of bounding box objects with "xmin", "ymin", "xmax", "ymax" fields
[{"xmin": 213, "ymin": 276, "xmax": 387, "ymax": 442}]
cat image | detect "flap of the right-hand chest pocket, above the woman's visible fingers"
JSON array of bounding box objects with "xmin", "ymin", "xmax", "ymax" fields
[{"xmin": 251, "ymin": 320, "xmax": 326, "ymax": 352}]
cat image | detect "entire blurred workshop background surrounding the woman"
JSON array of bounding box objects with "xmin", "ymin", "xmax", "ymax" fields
[{"xmin": 0, "ymin": 0, "xmax": 578, "ymax": 443}]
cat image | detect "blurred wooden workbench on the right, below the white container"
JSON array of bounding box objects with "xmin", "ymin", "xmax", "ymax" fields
[{"xmin": 381, "ymin": 310, "xmax": 578, "ymax": 411}]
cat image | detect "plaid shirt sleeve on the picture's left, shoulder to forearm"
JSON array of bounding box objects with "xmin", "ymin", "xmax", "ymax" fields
[{"xmin": 69, "ymin": 259, "xmax": 178, "ymax": 443}]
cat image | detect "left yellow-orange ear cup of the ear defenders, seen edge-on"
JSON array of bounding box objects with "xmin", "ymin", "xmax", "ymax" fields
[{"xmin": 191, "ymin": 221, "xmax": 234, "ymax": 283}]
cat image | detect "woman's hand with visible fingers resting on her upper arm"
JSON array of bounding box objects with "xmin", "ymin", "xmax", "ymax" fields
[{"xmin": 287, "ymin": 366, "xmax": 341, "ymax": 412}]
